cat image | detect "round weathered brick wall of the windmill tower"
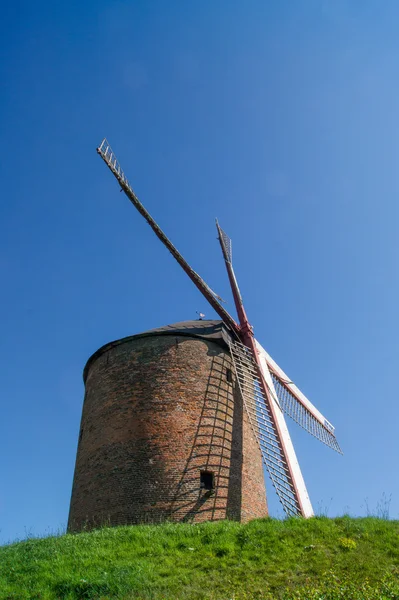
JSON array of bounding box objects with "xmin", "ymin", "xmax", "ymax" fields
[{"xmin": 68, "ymin": 335, "xmax": 267, "ymax": 531}]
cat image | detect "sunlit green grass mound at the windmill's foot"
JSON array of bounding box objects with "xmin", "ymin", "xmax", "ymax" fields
[{"xmin": 0, "ymin": 516, "xmax": 399, "ymax": 600}]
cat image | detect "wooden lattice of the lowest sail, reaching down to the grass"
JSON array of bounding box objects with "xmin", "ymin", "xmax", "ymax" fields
[{"xmin": 230, "ymin": 342, "xmax": 301, "ymax": 515}]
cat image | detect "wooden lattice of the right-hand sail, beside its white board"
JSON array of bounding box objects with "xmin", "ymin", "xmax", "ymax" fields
[{"xmin": 271, "ymin": 371, "xmax": 342, "ymax": 454}]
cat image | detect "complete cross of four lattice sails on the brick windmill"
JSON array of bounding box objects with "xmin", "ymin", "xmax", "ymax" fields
[{"xmin": 97, "ymin": 139, "xmax": 342, "ymax": 517}]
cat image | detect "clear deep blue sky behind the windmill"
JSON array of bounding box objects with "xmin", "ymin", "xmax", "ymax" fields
[{"xmin": 0, "ymin": 0, "xmax": 399, "ymax": 542}]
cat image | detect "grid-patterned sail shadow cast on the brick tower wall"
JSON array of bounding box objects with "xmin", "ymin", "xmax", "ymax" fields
[{"xmin": 169, "ymin": 353, "xmax": 243, "ymax": 522}]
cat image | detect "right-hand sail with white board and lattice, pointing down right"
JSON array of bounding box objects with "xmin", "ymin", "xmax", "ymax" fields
[{"xmin": 256, "ymin": 341, "xmax": 342, "ymax": 454}]
